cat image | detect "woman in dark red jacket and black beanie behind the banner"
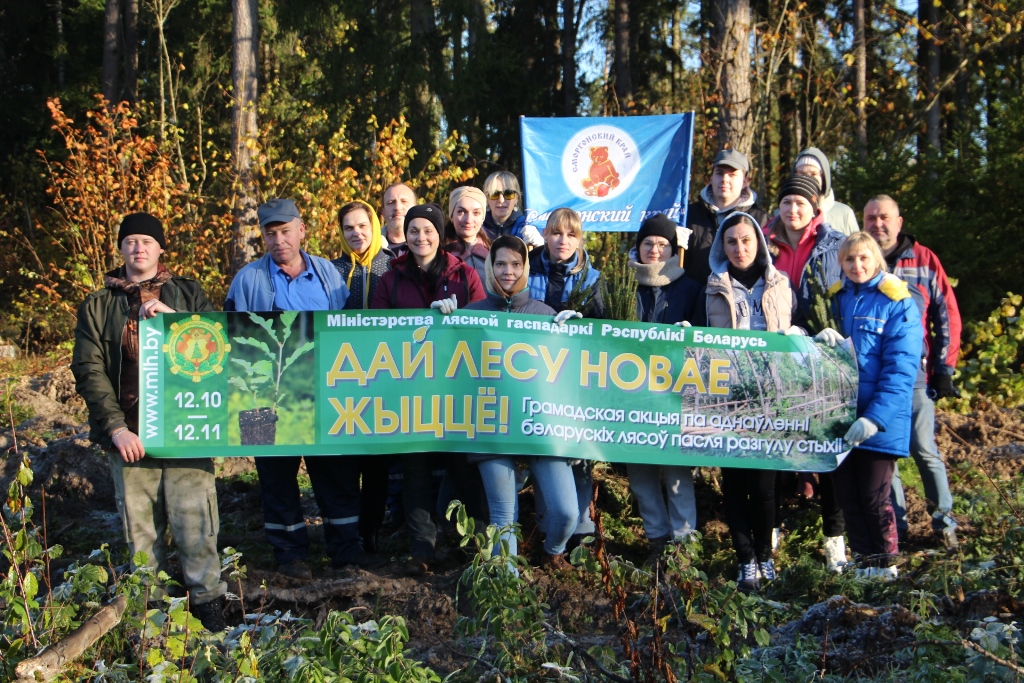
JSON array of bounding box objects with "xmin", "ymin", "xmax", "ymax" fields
[{"xmin": 371, "ymin": 204, "xmax": 486, "ymax": 575}]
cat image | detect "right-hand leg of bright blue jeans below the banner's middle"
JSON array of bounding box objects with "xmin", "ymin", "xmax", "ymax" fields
[{"xmin": 529, "ymin": 458, "xmax": 593, "ymax": 555}]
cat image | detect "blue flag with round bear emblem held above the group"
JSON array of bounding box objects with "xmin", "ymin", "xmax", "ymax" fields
[{"xmin": 520, "ymin": 113, "xmax": 693, "ymax": 231}]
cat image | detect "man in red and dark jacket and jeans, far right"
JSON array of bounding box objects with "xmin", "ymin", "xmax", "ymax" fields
[{"xmin": 864, "ymin": 195, "xmax": 961, "ymax": 550}]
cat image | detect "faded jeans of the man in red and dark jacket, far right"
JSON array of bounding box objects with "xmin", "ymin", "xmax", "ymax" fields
[{"xmin": 891, "ymin": 387, "xmax": 956, "ymax": 532}]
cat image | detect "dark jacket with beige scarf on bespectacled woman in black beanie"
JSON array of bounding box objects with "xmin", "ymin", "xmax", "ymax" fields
[{"xmin": 629, "ymin": 251, "xmax": 703, "ymax": 325}]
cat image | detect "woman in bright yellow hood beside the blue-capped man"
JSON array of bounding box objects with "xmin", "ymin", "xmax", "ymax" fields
[{"xmin": 333, "ymin": 200, "xmax": 394, "ymax": 310}]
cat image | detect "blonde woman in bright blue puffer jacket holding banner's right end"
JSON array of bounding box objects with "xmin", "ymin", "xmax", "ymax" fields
[{"xmin": 815, "ymin": 232, "xmax": 923, "ymax": 579}]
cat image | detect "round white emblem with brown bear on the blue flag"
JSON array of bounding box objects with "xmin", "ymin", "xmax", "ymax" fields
[{"xmin": 562, "ymin": 125, "xmax": 640, "ymax": 202}]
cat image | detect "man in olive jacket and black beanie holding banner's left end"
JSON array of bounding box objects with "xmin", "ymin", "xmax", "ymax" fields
[{"xmin": 71, "ymin": 213, "xmax": 227, "ymax": 631}]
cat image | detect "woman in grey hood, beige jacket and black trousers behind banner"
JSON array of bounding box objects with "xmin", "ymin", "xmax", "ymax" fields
[{"xmin": 707, "ymin": 212, "xmax": 804, "ymax": 591}]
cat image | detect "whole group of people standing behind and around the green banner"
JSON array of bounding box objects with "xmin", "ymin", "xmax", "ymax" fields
[{"xmin": 72, "ymin": 148, "xmax": 959, "ymax": 629}]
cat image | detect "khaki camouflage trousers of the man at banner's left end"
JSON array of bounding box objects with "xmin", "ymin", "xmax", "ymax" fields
[{"xmin": 106, "ymin": 453, "xmax": 227, "ymax": 605}]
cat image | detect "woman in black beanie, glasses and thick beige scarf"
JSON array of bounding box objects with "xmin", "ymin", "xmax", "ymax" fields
[{"xmin": 626, "ymin": 214, "xmax": 703, "ymax": 557}]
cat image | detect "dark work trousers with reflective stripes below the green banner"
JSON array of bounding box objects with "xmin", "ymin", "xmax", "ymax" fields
[{"xmin": 256, "ymin": 456, "xmax": 362, "ymax": 565}]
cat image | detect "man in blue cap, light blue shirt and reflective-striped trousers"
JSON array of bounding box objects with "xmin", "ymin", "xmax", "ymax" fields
[{"xmin": 224, "ymin": 199, "xmax": 382, "ymax": 580}]
